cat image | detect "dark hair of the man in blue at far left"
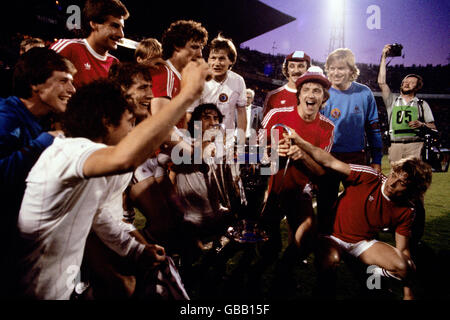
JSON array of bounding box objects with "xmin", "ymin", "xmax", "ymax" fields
[{"xmin": 12, "ymin": 47, "xmax": 77, "ymax": 99}]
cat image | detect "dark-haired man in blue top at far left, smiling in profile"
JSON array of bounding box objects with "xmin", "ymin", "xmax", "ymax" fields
[{"xmin": 0, "ymin": 48, "xmax": 76, "ymax": 297}]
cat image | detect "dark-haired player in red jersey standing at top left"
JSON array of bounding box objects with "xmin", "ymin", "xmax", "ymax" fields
[{"xmin": 50, "ymin": 0, "xmax": 129, "ymax": 88}]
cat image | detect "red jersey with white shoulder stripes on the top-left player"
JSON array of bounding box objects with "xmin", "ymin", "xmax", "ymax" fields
[{"xmin": 50, "ymin": 39, "xmax": 119, "ymax": 88}]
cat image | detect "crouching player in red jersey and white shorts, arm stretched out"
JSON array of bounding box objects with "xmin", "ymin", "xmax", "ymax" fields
[{"xmin": 278, "ymin": 131, "xmax": 432, "ymax": 300}]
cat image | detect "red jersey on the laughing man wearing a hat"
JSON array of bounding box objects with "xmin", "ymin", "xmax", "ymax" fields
[{"xmin": 260, "ymin": 107, "xmax": 334, "ymax": 193}]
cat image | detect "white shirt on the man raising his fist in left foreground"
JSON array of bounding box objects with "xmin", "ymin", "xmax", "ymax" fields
[{"xmin": 18, "ymin": 137, "xmax": 144, "ymax": 300}]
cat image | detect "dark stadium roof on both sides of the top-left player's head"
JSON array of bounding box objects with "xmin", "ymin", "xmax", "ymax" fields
[{"xmin": 4, "ymin": 0, "xmax": 295, "ymax": 45}]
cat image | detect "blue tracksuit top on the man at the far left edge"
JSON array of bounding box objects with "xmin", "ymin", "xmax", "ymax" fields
[{"xmin": 0, "ymin": 96, "xmax": 53, "ymax": 214}]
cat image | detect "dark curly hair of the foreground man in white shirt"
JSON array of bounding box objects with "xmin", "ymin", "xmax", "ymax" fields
[{"xmin": 62, "ymin": 79, "xmax": 133, "ymax": 140}]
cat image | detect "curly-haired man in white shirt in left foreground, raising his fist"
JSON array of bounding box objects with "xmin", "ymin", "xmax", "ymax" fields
[{"xmin": 18, "ymin": 60, "xmax": 209, "ymax": 299}]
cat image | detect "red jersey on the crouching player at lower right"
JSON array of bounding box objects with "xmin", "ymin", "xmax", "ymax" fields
[{"xmin": 333, "ymin": 164, "xmax": 414, "ymax": 243}]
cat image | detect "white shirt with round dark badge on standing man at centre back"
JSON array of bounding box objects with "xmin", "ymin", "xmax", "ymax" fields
[{"xmin": 188, "ymin": 70, "xmax": 247, "ymax": 130}]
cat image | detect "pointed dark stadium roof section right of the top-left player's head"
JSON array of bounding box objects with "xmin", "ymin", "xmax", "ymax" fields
[{"xmin": 124, "ymin": 0, "xmax": 295, "ymax": 44}]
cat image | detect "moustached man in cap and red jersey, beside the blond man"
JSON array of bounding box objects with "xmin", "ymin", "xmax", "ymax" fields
[{"xmin": 263, "ymin": 51, "xmax": 311, "ymax": 116}]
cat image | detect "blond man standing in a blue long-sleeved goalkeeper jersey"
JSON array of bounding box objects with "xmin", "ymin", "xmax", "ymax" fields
[{"xmin": 317, "ymin": 48, "xmax": 383, "ymax": 233}]
